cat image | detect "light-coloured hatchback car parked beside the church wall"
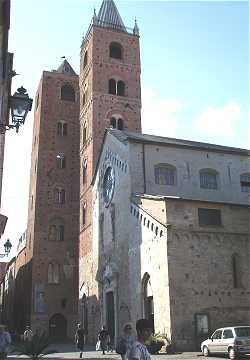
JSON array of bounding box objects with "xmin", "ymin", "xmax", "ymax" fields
[{"xmin": 201, "ymin": 326, "xmax": 250, "ymax": 360}]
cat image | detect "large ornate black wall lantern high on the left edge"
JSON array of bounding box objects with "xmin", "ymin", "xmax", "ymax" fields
[{"xmin": 0, "ymin": 86, "xmax": 33, "ymax": 133}]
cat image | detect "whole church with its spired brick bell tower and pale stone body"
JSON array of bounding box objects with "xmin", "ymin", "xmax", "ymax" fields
[{"xmin": 79, "ymin": 0, "xmax": 250, "ymax": 350}]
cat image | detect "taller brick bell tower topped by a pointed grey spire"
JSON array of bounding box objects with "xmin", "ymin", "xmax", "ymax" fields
[{"xmin": 79, "ymin": 0, "xmax": 141, "ymax": 342}]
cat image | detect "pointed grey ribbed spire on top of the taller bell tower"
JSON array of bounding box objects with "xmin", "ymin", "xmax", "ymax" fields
[{"xmin": 97, "ymin": 0, "xmax": 126, "ymax": 32}]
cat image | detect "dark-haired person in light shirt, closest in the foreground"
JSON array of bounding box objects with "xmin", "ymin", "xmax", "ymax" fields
[{"xmin": 128, "ymin": 319, "xmax": 152, "ymax": 360}]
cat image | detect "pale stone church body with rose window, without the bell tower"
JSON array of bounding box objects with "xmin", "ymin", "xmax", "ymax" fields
[{"xmin": 90, "ymin": 130, "xmax": 250, "ymax": 350}]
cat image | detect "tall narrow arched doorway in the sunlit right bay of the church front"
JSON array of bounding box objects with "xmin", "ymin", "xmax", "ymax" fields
[{"xmin": 142, "ymin": 273, "xmax": 155, "ymax": 332}]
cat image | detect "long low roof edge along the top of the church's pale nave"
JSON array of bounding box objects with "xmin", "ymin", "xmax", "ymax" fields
[{"xmin": 108, "ymin": 129, "xmax": 250, "ymax": 155}]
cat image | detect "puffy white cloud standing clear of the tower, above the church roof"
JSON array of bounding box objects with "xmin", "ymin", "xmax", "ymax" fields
[{"xmin": 194, "ymin": 102, "xmax": 241, "ymax": 135}]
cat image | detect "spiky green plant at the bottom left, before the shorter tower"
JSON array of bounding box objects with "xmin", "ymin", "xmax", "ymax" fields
[{"xmin": 12, "ymin": 333, "xmax": 57, "ymax": 360}]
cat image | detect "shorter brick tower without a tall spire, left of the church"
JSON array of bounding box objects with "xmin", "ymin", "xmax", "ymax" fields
[{"xmin": 24, "ymin": 60, "xmax": 80, "ymax": 341}]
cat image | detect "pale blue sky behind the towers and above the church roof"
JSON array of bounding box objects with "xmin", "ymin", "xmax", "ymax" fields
[{"xmin": 2, "ymin": 0, "xmax": 250, "ymax": 258}]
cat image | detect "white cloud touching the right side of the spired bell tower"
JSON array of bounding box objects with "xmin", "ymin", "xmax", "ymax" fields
[{"xmin": 141, "ymin": 88, "xmax": 181, "ymax": 137}]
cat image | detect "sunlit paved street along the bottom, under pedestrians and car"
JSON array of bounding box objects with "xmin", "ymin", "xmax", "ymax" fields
[{"xmin": 8, "ymin": 344, "xmax": 250, "ymax": 360}]
